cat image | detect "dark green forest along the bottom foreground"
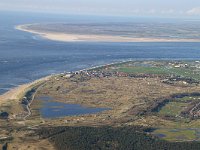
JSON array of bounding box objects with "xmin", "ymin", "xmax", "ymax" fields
[{"xmin": 37, "ymin": 126, "xmax": 200, "ymax": 150}]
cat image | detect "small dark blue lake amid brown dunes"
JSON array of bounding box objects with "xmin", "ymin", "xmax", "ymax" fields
[{"xmin": 38, "ymin": 96, "xmax": 109, "ymax": 118}]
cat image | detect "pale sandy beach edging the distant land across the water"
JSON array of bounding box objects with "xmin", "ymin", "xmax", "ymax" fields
[{"xmin": 15, "ymin": 24, "xmax": 200, "ymax": 43}]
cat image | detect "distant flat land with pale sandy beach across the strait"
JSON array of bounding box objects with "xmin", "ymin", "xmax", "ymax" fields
[{"xmin": 15, "ymin": 23, "xmax": 200, "ymax": 42}]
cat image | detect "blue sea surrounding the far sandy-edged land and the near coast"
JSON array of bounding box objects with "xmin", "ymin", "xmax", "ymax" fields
[{"xmin": 0, "ymin": 12, "xmax": 200, "ymax": 93}]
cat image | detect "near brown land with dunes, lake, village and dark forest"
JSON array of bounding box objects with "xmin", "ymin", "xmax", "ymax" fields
[{"xmin": 0, "ymin": 60, "xmax": 200, "ymax": 150}]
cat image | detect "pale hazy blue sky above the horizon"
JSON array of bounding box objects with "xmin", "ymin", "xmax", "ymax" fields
[{"xmin": 0, "ymin": 0, "xmax": 200, "ymax": 18}]
